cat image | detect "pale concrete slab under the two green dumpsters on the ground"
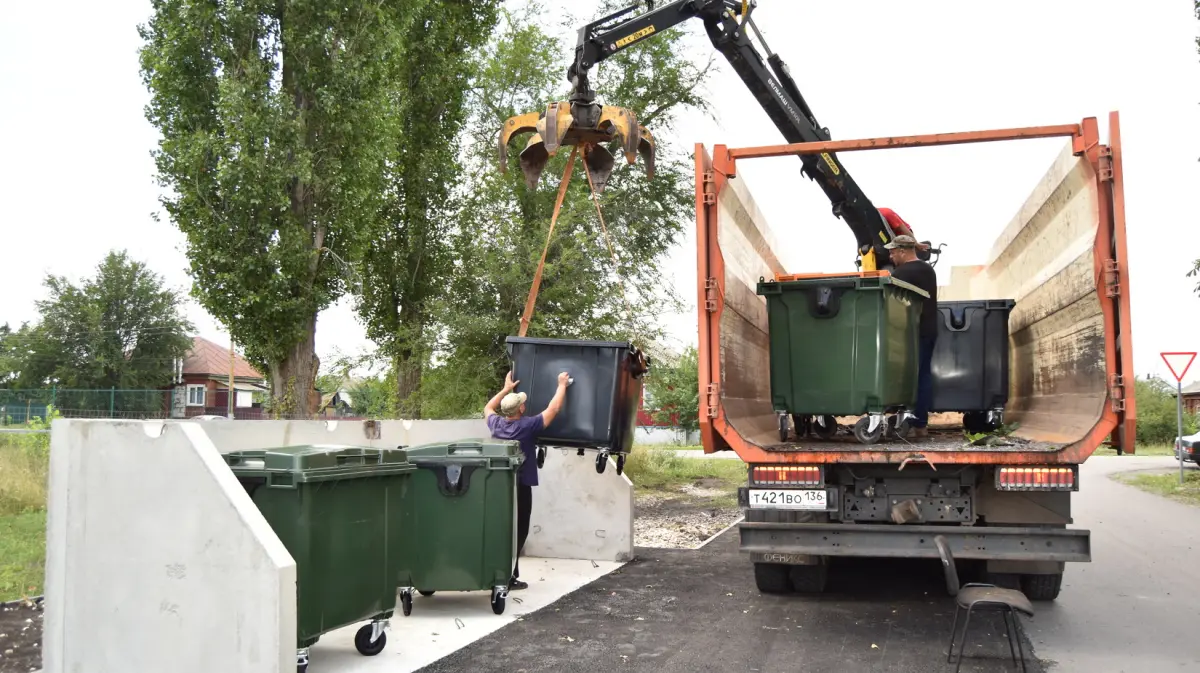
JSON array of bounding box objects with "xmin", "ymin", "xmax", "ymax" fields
[{"xmin": 308, "ymin": 558, "xmax": 623, "ymax": 673}]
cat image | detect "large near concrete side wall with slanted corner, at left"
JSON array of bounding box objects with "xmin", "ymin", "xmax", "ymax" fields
[{"xmin": 42, "ymin": 420, "xmax": 296, "ymax": 673}]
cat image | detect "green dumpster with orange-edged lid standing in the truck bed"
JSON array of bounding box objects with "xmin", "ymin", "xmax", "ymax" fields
[{"xmin": 757, "ymin": 272, "xmax": 929, "ymax": 440}]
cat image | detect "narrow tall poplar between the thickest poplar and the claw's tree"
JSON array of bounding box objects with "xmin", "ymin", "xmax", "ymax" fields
[{"xmin": 358, "ymin": 0, "xmax": 500, "ymax": 417}]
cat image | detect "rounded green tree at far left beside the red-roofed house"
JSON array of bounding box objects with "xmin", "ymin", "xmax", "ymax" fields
[{"xmin": 5, "ymin": 251, "xmax": 192, "ymax": 390}]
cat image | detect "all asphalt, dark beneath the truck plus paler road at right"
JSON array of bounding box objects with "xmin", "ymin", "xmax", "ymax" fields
[{"xmin": 421, "ymin": 457, "xmax": 1200, "ymax": 673}]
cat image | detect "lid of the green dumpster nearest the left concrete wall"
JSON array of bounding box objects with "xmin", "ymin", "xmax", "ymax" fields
[{"xmin": 224, "ymin": 445, "xmax": 416, "ymax": 483}]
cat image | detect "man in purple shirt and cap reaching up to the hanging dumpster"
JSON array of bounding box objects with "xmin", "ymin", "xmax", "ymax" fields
[{"xmin": 484, "ymin": 372, "xmax": 571, "ymax": 590}]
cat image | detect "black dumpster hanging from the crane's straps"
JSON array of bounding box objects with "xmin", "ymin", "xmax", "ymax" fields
[{"xmin": 506, "ymin": 337, "xmax": 649, "ymax": 471}]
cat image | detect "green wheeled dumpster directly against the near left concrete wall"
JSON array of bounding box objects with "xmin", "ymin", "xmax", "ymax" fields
[{"xmin": 224, "ymin": 446, "xmax": 415, "ymax": 672}]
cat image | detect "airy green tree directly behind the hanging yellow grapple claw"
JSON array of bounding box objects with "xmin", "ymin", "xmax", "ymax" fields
[{"xmin": 422, "ymin": 2, "xmax": 712, "ymax": 417}]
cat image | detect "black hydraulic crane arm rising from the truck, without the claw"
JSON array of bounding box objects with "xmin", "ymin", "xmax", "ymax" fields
[{"xmin": 566, "ymin": 0, "xmax": 929, "ymax": 271}]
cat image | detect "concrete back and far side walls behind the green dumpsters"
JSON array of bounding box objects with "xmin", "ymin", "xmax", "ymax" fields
[{"xmin": 187, "ymin": 419, "xmax": 634, "ymax": 561}]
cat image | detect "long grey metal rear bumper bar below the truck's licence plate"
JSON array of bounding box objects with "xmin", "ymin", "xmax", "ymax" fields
[{"xmin": 738, "ymin": 522, "xmax": 1092, "ymax": 564}]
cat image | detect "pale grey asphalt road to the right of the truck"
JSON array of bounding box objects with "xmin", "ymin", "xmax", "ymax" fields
[{"xmin": 1027, "ymin": 456, "xmax": 1200, "ymax": 673}]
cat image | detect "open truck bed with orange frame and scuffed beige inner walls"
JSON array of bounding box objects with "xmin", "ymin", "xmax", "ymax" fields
[{"xmin": 695, "ymin": 113, "xmax": 1135, "ymax": 464}]
